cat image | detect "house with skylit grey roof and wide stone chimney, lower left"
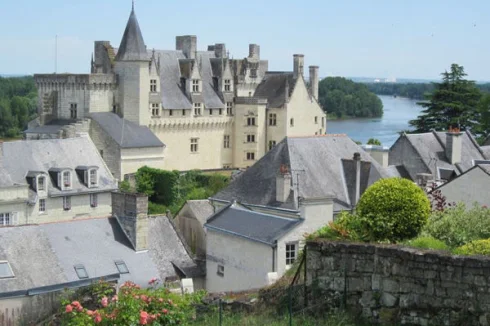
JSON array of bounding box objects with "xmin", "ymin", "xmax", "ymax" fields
[{"xmin": 0, "ymin": 193, "xmax": 204, "ymax": 325}]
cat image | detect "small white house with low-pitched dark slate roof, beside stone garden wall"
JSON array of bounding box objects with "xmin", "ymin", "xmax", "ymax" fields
[{"xmin": 204, "ymin": 197, "xmax": 333, "ymax": 293}]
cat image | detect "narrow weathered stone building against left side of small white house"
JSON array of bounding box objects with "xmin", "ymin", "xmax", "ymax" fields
[{"xmin": 174, "ymin": 199, "xmax": 214, "ymax": 259}]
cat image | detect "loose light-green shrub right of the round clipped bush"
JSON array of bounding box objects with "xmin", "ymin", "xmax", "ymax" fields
[{"xmin": 424, "ymin": 203, "xmax": 490, "ymax": 248}]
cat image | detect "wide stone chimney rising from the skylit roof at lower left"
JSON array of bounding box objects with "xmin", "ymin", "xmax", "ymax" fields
[{"xmin": 112, "ymin": 192, "xmax": 148, "ymax": 251}]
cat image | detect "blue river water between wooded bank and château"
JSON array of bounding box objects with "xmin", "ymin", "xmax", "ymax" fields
[{"xmin": 327, "ymin": 95, "xmax": 423, "ymax": 147}]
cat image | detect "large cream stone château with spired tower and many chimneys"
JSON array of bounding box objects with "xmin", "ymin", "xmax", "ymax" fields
[{"xmin": 26, "ymin": 8, "xmax": 327, "ymax": 178}]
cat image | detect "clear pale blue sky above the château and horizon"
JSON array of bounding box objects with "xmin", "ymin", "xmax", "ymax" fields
[{"xmin": 0, "ymin": 0, "xmax": 490, "ymax": 81}]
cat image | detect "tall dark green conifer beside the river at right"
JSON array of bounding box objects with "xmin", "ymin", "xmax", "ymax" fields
[{"xmin": 410, "ymin": 64, "xmax": 481, "ymax": 132}]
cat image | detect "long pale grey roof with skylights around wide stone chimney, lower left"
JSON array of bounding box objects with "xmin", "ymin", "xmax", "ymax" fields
[{"xmin": 0, "ymin": 216, "xmax": 201, "ymax": 293}]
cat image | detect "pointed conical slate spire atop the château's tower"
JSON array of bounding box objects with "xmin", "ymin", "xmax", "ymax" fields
[{"xmin": 116, "ymin": 4, "xmax": 148, "ymax": 61}]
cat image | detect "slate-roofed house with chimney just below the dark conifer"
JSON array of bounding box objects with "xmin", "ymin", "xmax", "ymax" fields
[{"xmin": 389, "ymin": 131, "xmax": 490, "ymax": 184}]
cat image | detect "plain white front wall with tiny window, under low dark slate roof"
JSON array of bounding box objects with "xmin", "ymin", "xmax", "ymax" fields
[{"xmin": 206, "ymin": 229, "xmax": 273, "ymax": 293}]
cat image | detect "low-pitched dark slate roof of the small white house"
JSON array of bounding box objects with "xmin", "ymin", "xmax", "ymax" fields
[{"xmin": 204, "ymin": 203, "xmax": 303, "ymax": 246}]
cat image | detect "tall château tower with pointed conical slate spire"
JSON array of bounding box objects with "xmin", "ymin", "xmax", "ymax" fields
[{"xmin": 114, "ymin": 7, "xmax": 150, "ymax": 125}]
